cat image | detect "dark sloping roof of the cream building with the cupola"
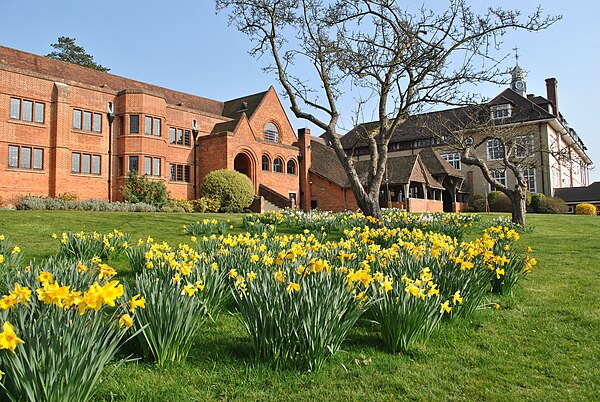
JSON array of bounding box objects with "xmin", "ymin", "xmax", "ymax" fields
[{"xmin": 341, "ymin": 88, "xmax": 555, "ymax": 149}]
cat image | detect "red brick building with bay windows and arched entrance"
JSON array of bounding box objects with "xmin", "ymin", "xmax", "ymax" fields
[{"xmin": 0, "ymin": 46, "xmax": 299, "ymax": 204}]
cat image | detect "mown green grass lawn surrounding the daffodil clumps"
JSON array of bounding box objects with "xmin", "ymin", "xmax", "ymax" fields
[{"xmin": 0, "ymin": 211, "xmax": 600, "ymax": 401}]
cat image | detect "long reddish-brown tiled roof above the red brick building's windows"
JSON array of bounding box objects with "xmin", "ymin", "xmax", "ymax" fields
[{"xmin": 0, "ymin": 46, "xmax": 224, "ymax": 116}]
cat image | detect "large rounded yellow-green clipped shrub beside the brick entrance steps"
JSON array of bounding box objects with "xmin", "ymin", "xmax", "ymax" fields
[{"xmin": 202, "ymin": 169, "xmax": 254, "ymax": 212}]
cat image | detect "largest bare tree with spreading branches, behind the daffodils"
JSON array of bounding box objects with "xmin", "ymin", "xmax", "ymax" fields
[{"xmin": 216, "ymin": 0, "xmax": 559, "ymax": 218}]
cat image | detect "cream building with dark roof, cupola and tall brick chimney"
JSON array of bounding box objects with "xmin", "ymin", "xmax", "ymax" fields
[{"xmin": 341, "ymin": 66, "xmax": 592, "ymax": 203}]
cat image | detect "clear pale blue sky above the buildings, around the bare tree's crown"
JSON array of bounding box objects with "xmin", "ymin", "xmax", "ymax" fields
[{"xmin": 0, "ymin": 0, "xmax": 600, "ymax": 181}]
